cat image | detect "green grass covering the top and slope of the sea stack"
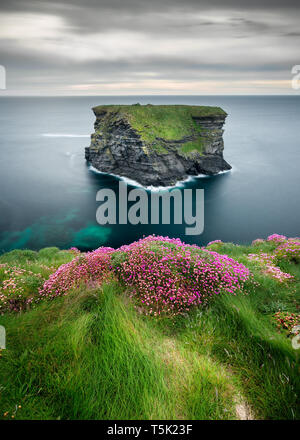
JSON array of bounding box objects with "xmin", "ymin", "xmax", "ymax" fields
[{"xmin": 93, "ymin": 104, "xmax": 226, "ymax": 152}]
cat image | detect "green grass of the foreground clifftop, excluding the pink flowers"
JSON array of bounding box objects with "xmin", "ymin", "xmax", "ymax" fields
[{"xmin": 0, "ymin": 237, "xmax": 300, "ymax": 419}]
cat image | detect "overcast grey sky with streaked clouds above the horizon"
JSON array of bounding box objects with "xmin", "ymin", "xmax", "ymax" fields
[{"xmin": 0, "ymin": 0, "xmax": 300, "ymax": 96}]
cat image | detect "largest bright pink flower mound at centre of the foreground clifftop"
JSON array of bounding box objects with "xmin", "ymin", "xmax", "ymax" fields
[{"xmin": 116, "ymin": 236, "xmax": 250, "ymax": 315}]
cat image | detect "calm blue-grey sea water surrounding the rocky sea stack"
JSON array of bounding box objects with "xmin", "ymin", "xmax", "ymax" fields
[{"xmin": 0, "ymin": 96, "xmax": 300, "ymax": 252}]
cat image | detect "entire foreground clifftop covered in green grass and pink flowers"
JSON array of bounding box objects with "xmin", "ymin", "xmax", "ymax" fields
[{"xmin": 0, "ymin": 234, "xmax": 300, "ymax": 419}]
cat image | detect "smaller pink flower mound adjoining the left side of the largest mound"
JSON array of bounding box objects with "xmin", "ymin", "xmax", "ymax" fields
[{"xmin": 37, "ymin": 247, "xmax": 114, "ymax": 301}]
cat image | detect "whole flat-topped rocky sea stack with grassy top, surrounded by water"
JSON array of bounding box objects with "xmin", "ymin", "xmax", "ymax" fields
[{"xmin": 85, "ymin": 105, "xmax": 231, "ymax": 186}]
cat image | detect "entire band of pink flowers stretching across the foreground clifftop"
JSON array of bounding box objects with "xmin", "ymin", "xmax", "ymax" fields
[{"xmin": 0, "ymin": 234, "xmax": 300, "ymax": 315}]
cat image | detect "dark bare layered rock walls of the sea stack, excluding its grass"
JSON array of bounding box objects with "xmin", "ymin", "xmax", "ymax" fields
[{"xmin": 85, "ymin": 106, "xmax": 231, "ymax": 186}]
